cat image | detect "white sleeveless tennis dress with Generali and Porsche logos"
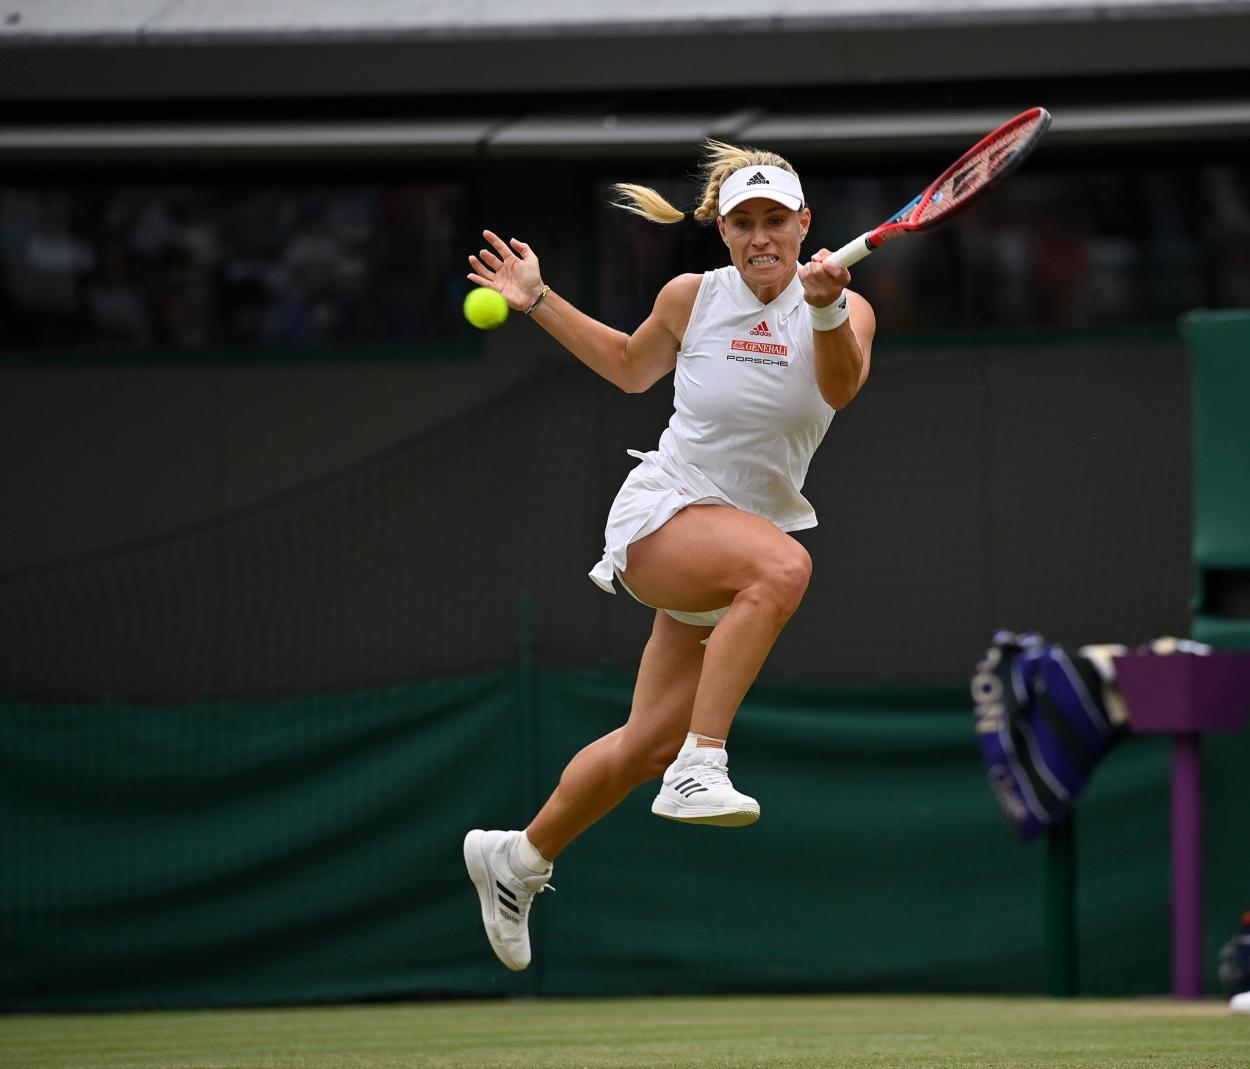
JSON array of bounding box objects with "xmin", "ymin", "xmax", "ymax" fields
[{"xmin": 590, "ymin": 266, "xmax": 834, "ymax": 625}]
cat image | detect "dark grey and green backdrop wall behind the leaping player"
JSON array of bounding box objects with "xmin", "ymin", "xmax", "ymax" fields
[{"xmin": 0, "ymin": 335, "xmax": 1250, "ymax": 1009}]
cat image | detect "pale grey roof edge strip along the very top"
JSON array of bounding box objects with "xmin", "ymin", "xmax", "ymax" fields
[{"xmin": 0, "ymin": 0, "xmax": 1250, "ymax": 48}]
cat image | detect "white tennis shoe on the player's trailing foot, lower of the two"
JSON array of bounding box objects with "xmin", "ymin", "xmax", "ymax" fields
[{"xmin": 465, "ymin": 828, "xmax": 555, "ymax": 973}]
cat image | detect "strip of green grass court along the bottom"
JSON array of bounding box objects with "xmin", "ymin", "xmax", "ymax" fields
[{"xmin": 0, "ymin": 995, "xmax": 1250, "ymax": 1069}]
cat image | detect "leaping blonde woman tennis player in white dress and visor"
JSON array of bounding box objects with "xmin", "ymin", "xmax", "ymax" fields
[{"xmin": 464, "ymin": 141, "xmax": 876, "ymax": 969}]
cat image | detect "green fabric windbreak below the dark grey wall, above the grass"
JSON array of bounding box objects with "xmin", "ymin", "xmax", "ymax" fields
[{"xmin": 0, "ymin": 669, "xmax": 1250, "ymax": 1010}]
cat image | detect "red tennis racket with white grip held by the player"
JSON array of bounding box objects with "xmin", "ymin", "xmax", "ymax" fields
[{"xmin": 829, "ymin": 108, "xmax": 1050, "ymax": 268}]
